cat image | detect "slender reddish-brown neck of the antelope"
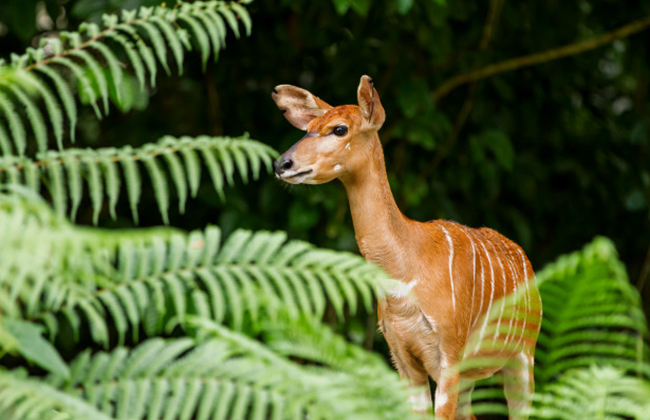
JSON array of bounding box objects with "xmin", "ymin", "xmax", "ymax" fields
[{"xmin": 342, "ymin": 135, "xmax": 412, "ymax": 278}]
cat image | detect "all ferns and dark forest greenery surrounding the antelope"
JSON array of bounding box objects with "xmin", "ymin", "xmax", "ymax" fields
[{"xmin": 0, "ymin": 0, "xmax": 650, "ymax": 419}]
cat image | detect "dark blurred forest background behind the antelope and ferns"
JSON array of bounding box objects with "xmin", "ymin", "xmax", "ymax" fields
[{"xmin": 0, "ymin": 0, "xmax": 650, "ymax": 313}]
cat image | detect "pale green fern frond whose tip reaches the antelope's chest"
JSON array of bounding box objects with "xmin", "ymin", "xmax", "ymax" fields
[{"xmin": 0, "ymin": 190, "xmax": 385, "ymax": 345}]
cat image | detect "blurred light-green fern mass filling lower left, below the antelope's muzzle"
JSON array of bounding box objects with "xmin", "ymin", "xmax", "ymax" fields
[{"xmin": 0, "ymin": 191, "xmax": 410, "ymax": 419}]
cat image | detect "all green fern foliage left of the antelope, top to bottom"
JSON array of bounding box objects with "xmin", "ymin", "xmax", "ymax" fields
[{"xmin": 0, "ymin": 2, "xmax": 415, "ymax": 420}]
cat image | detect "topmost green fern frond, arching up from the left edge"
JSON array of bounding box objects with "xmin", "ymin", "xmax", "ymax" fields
[{"xmin": 0, "ymin": 1, "xmax": 251, "ymax": 157}]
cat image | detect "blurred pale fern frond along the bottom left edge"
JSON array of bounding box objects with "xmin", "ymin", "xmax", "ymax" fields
[{"xmin": 0, "ymin": 334, "xmax": 417, "ymax": 420}]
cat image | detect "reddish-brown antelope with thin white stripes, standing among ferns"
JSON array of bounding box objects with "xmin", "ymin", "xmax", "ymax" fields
[{"xmin": 274, "ymin": 76, "xmax": 541, "ymax": 419}]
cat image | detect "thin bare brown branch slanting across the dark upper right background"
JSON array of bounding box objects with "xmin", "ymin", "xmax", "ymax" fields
[{"xmin": 433, "ymin": 16, "xmax": 650, "ymax": 101}]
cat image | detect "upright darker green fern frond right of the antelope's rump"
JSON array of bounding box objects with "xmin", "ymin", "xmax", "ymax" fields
[{"xmin": 536, "ymin": 238, "xmax": 650, "ymax": 384}]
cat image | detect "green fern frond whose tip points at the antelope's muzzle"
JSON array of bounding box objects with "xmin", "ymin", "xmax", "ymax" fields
[{"xmin": 0, "ymin": 135, "xmax": 277, "ymax": 223}]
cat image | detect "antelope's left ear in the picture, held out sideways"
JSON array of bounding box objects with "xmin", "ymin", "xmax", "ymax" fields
[{"xmin": 272, "ymin": 85, "xmax": 331, "ymax": 131}]
